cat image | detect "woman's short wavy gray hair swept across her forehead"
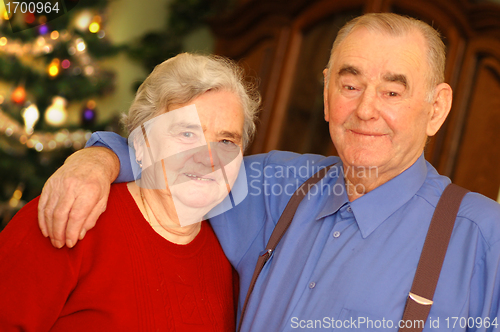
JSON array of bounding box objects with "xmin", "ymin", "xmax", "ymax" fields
[{"xmin": 122, "ymin": 53, "xmax": 260, "ymax": 149}]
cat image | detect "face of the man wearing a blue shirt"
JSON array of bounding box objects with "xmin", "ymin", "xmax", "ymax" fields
[{"xmin": 325, "ymin": 28, "xmax": 434, "ymax": 177}]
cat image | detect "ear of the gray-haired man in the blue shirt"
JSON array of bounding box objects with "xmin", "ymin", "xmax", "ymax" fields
[{"xmin": 427, "ymin": 83, "xmax": 453, "ymax": 136}]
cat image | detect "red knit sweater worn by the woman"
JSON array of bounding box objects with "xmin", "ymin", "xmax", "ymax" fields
[{"xmin": 0, "ymin": 184, "xmax": 235, "ymax": 332}]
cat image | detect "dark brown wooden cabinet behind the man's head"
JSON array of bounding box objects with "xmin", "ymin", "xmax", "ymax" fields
[{"xmin": 211, "ymin": 0, "xmax": 500, "ymax": 200}]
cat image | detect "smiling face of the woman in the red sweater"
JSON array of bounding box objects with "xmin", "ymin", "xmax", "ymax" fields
[{"xmin": 138, "ymin": 91, "xmax": 244, "ymax": 226}]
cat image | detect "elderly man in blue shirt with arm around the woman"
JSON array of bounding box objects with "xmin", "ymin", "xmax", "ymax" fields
[{"xmin": 39, "ymin": 14, "xmax": 500, "ymax": 332}]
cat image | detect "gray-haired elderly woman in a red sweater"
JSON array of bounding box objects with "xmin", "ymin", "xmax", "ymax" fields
[{"xmin": 0, "ymin": 54, "xmax": 259, "ymax": 332}]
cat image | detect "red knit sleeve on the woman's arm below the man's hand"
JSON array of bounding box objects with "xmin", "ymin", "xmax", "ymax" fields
[{"xmin": 0, "ymin": 198, "xmax": 78, "ymax": 331}]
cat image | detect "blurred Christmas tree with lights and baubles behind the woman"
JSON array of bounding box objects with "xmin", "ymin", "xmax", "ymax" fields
[{"xmin": 0, "ymin": 0, "xmax": 119, "ymax": 229}]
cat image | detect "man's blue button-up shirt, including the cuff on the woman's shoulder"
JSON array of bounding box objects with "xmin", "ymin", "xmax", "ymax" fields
[{"xmin": 88, "ymin": 133, "xmax": 500, "ymax": 332}]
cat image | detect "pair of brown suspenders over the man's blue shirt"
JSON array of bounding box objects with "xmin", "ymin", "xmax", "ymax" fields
[{"xmin": 237, "ymin": 161, "xmax": 469, "ymax": 332}]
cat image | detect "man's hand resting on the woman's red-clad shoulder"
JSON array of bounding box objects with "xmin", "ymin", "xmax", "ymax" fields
[{"xmin": 38, "ymin": 147, "xmax": 120, "ymax": 248}]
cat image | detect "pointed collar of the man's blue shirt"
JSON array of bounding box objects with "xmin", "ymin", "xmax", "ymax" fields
[{"xmin": 316, "ymin": 153, "xmax": 427, "ymax": 238}]
